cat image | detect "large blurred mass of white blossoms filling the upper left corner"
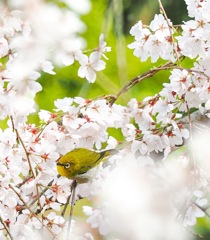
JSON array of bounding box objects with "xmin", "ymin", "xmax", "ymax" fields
[{"xmin": 0, "ymin": 1, "xmax": 92, "ymax": 124}]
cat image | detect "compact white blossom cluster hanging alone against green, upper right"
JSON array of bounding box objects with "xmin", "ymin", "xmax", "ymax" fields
[{"xmin": 129, "ymin": 14, "xmax": 176, "ymax": 62}]
